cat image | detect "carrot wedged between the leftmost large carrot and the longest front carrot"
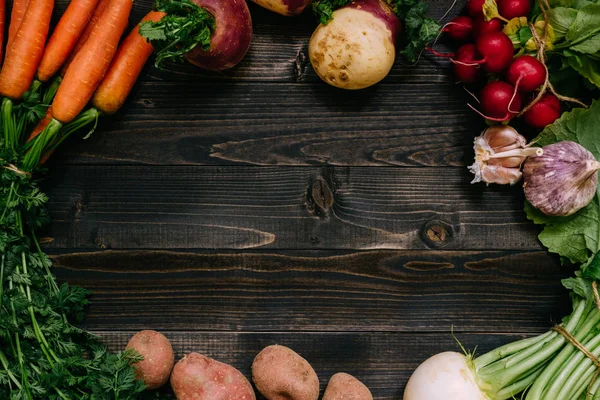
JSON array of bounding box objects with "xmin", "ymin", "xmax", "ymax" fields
[{"xmin": 37, "ymin": 0, "xmax": 98, "ymax": 82}]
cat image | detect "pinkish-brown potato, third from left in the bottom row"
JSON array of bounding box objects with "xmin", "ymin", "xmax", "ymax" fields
[{"xmin": 252, "ymin": 345, "xmax": 319, "ymax": 400}]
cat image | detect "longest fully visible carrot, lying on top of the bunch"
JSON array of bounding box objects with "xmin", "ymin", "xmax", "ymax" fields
[{"xmin": 52, "ymin": 0, "xmax": 133, "ymax": 124}]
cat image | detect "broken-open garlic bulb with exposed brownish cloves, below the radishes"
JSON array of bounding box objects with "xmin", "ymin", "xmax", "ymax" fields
[{"xmin": 469, "ymin": 125, "xmax": 542, "ymax": 185}]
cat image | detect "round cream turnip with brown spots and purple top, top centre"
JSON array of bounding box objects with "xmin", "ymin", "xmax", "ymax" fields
[{"xmin": 308, "ymin": 0, "xmax": 401, "ymax": 89}]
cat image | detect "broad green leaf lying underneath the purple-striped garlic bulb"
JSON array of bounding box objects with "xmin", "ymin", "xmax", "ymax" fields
[{"xmin": 525, "ymin": 101, "xmax": 600, "ymax": 263}]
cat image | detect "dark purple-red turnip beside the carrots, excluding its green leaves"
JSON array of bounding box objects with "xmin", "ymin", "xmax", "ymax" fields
[{"xmin": 185, "ymin": 0, "xmax": 252, "ymax": 71}]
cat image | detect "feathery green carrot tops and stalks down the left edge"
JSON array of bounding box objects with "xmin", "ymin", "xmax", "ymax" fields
[{"xmin": 0, "ymin": 77, "xmax": 144, "ymax": 400}]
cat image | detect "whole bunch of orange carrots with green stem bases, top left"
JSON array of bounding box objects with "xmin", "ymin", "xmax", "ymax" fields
[{"xmin": 0, "ymin": 0, "xmax": 164, "ymax": 171}]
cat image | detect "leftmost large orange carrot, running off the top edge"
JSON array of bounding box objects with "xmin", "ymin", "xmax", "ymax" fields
[{"xmin": 0, "ymin": 0, "xmax": 54, "ymax": 99}]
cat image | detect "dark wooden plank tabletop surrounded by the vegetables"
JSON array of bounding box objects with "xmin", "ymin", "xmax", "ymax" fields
[{"xmin": 45, "ymin": 0, "xmax": 570, "ymax": 400}]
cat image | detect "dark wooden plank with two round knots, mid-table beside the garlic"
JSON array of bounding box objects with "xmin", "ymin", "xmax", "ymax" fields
[{"xmin": 45, "ymin": 166, "xmax": 541, "ymax": 250}]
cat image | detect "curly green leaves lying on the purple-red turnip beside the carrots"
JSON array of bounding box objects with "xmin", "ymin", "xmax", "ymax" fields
[{"xmin": 139, "ymin": 0, "xmax": 215, "ymax": 68}]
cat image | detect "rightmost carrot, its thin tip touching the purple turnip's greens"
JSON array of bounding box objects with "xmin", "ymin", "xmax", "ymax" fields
[{"xmin": 92, "ymin": 11, "xmax": 166, "ymax": 115}]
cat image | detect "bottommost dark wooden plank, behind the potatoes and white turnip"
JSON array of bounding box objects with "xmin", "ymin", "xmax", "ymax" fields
[{"xmin": 97, "ymin": 331, "xmax": 544, "ymax": 400}]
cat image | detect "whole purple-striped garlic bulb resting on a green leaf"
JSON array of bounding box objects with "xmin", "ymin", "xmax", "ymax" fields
[{"xmin": 523, "ymin": 141, "xmax": 600, "ymax": 216}]
